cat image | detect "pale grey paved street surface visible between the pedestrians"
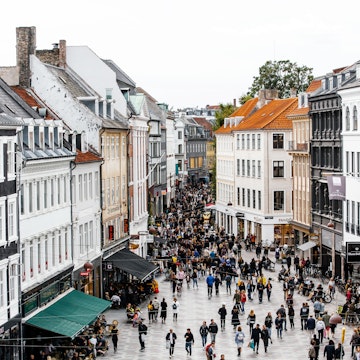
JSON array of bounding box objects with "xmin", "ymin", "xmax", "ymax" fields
[{"xmin": 105, "ymin": 250, "xmax": 353, "ymax": 360}]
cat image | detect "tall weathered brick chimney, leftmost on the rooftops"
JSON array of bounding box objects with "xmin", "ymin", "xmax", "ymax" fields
[{"xmin": 16, "ymin": 26, "xmax": 36, "ymax": 88}]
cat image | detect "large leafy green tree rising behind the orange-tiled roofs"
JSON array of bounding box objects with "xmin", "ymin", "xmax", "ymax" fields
[{"xmin": 248, "ymin": 60, "xmax": 314, "ymax": 98}]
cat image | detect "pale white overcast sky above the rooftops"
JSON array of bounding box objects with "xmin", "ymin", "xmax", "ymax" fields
[{"xmin": 0, "ymin": 0, "xmax": 360, "ymax": 109}]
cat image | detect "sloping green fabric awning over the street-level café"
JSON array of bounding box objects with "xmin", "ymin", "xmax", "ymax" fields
[{"xmin": 26, "ymin": 290, "xmax": 111, "ymax": 338}]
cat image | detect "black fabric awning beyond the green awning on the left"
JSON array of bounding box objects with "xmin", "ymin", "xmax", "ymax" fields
[{"xmin": 106, "ymin": 249, "xmax": 158, "ymax": 281}]
